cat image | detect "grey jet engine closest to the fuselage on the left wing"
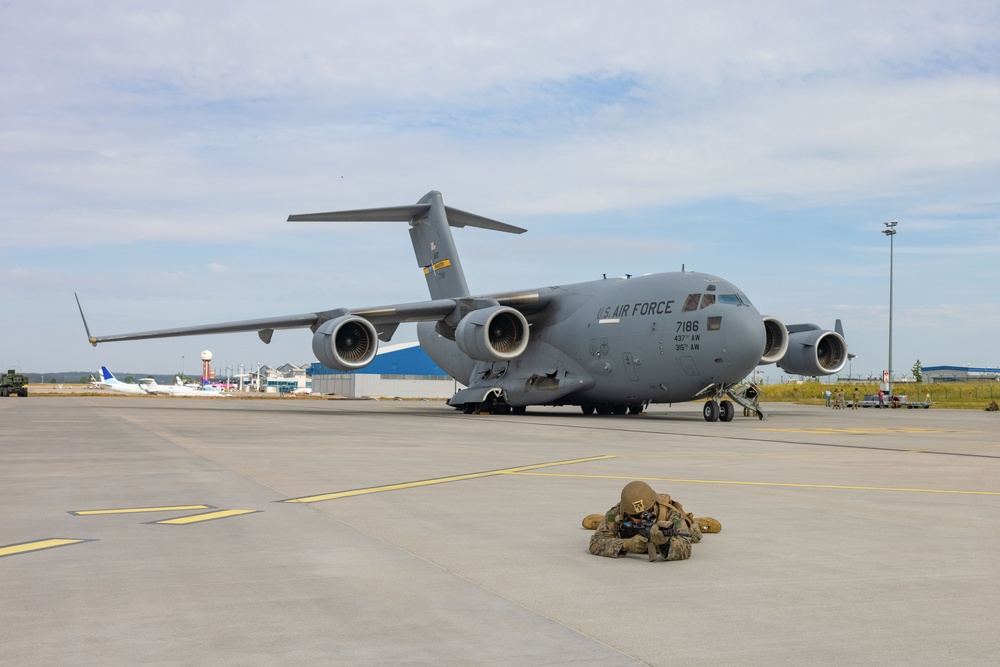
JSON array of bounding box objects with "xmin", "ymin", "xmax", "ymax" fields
[{"xmin": 455, "ymin": 306, "xmax": 528, "ymax": 362}]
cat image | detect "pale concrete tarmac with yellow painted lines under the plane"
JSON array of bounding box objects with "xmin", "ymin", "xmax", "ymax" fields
[{"xmin": 0, "ymin": 396, "xmax": 1000, "ymax": 666}]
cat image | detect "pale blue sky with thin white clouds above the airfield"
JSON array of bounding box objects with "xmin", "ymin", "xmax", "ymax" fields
[{"xmin": 0, "ymin": 0, "xmax": 1000, "ymax": 379}]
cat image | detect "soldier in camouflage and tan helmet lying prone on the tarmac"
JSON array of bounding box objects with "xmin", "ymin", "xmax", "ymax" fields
[{"xmin": 584, "ymin": 481, "xmax": 722, "ymax": 561}]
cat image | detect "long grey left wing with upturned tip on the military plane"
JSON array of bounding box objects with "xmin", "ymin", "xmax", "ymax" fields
[{"xmin": 74, "ymin": 295, "xmax": 456, "ymax": 346}]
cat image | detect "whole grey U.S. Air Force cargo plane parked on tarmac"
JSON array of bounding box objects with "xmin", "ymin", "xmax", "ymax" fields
[{"xmin": 80, "ymin": 191, "xmax": 848, "ymax": 421}]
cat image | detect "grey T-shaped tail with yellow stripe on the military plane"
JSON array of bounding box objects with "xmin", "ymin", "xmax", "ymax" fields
[{"xmin": 288, "ymin": 190, "xmax": 527, "ymax": 299}]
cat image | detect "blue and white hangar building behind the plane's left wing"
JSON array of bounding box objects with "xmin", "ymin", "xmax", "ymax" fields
[{"xmin": 310, "ymin": 342, "xmax": 465, "ymax": 399}]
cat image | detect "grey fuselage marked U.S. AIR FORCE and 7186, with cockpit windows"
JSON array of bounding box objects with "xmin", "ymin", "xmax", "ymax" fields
[{"xmin": 418, "ymin": 273, "xmax": 765, "ymax": 406}]
